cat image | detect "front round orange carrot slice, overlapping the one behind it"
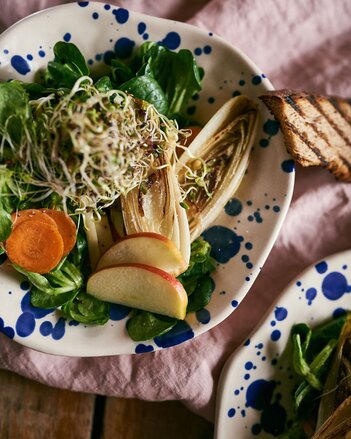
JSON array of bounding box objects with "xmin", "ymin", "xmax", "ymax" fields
[{"xmin": 6, "ymin": 218, "xmax": 63, "ymax": 274}]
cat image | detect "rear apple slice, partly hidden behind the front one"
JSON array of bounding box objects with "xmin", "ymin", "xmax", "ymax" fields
[{"xmin": 97, "ymin": 232, "xmax": 187, "ymax": 276}]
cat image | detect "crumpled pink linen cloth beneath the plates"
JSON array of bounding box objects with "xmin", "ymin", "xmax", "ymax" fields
[{"xmin": 0, "ymin": 0, "xmax": 351, "ymax": 420}]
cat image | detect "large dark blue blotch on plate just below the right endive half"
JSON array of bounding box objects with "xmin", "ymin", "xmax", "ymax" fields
[{"xmin": 202, "ymin": 226, "xmax": 244, "ymax": 264}]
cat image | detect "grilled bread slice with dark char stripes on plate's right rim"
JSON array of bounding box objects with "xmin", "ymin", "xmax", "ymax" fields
[{"xmin": 260, "ymin": 90, "xmax": 351, "ymax": 181}]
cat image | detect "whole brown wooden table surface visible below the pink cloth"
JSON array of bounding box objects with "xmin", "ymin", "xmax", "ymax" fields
[{"xmin": 0, "ymin": 370, "xmax": 213, "ymax": 439}]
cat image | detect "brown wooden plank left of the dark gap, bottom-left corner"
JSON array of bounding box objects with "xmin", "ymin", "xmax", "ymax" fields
[{"xmin": 0, "ymin": 370, "xmax": 95, "ymax": 439}]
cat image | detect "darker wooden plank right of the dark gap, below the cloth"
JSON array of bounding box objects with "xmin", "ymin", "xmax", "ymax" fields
[{"xmin": 101, "ymin": 398, "xmax": 213, "ymax": 439}]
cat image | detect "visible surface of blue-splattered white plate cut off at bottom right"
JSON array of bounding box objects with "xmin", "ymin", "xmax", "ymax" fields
[{"xmin": 215, "ymin": 250, "xmax": 351, "ymax": 439}]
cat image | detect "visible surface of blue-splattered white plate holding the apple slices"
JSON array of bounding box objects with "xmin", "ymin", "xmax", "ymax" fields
[{"xmin": 0, "ymin": 2, "xmax": 294, "ymax": 356}]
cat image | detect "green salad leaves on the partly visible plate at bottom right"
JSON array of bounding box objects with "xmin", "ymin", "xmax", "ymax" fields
[{"xmin": 279, "ymin": 314, "xmax": 347, "ymax": 439}]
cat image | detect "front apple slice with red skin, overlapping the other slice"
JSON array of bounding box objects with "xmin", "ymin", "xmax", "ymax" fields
[{"xmin": 87, "ymin": 264, "xmax": 188, "ymax": 320}]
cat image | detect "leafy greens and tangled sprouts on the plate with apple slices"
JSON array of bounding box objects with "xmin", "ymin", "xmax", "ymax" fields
[{"xmin": 0, "ymin": 42, "xmax": 215, "ymax": 340}]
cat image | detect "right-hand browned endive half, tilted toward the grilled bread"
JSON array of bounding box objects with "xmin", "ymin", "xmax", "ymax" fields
[{"xmin": 176, "ymin": 96, "xmax": 258, "ymax": 241}]
